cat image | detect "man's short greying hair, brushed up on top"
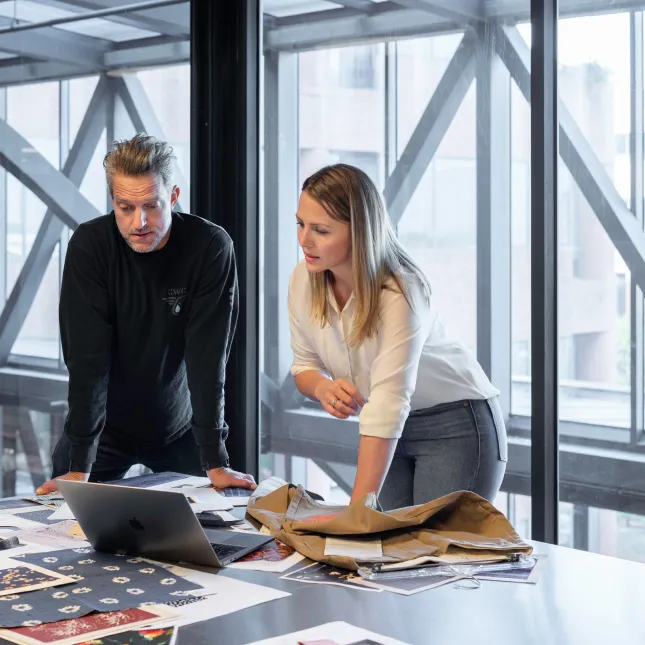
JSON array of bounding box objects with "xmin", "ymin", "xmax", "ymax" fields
[{"xmin": 103, "ymin": 132, "xmax": 175, "ymax": 195}]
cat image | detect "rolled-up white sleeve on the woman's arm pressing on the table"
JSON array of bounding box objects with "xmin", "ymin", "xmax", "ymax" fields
[{"xmin": 359, "ymin": 289, "xmax": 430, "ymax": 439}]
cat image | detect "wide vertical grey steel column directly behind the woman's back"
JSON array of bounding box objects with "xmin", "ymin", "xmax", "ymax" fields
[{"xmin": 476, "ymin": 24, "xmax": 512, "ymax": 417}]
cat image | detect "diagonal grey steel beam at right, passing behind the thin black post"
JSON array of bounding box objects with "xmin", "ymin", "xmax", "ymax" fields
[{"xmin": 498, "ymin": 27, "xmax": 645, "ymax": 290}]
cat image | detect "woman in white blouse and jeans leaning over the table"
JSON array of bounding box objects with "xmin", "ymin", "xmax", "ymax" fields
[{"xmin": 288, "ymin": 164, "xmax": 507, "ymax": 510}]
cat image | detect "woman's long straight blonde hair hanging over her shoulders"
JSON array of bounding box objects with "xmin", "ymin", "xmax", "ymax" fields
[{"xmin": 302, "ymin": 164, "xmax": 430, "ymax": 346}]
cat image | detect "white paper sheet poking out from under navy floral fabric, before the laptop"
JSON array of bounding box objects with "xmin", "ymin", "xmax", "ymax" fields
[{"xmin": 152, "ymin": 567, "xmax": 288, "ymax": 628}]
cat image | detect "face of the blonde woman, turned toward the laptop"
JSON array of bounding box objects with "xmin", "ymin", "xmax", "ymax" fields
[{"xmin": 296, "ymin": 190, "xmax": 351, "ymax": 273}]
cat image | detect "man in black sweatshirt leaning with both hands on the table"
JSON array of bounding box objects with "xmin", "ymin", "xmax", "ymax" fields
[{"xmin": 37, "ymin": 134, "xmax": 255, "ymax": 494}]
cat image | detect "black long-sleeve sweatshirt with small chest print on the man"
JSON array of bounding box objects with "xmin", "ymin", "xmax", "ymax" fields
[{"xmin": 59, "ymin": 213, "xmax": 239, "ymax": 472}]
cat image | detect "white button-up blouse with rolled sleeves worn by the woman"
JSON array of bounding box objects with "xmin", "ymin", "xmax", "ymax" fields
[{"xmin": 288, "ymin": 261, "xmax": 499, "ymax": 439}]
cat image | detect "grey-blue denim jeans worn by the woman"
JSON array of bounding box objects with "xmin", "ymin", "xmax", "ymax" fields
[{"xmin": 379, "ymin": 397, "xmax": 508, "ymax": 510}]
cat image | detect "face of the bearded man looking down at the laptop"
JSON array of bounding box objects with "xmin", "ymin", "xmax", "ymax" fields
[{"xmin": 112, "ymin": 174, "xmax": 179, "ymax": 253}]
